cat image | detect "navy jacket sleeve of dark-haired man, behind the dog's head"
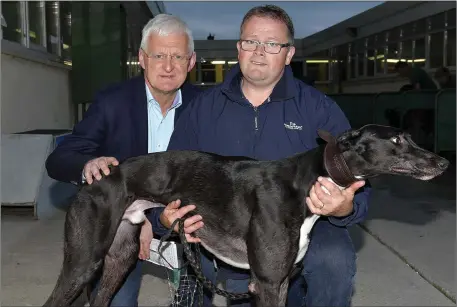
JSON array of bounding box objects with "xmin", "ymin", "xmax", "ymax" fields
[{"xmin": 315, "ymin": 96, "xmax": 372, "ymax": 226}]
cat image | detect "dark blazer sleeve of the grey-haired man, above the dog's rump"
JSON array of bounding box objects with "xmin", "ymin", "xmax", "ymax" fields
[{"xmin": 46, "ymin": 97, "xmax": 106, "ymax": 184}]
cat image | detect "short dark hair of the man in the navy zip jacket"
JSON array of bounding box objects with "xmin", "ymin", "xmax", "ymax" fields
[{"xmin": 240, "ymin": 5, "xmax": 295, "ymax": 45}]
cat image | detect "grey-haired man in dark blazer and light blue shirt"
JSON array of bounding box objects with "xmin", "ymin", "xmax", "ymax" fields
[{"xmin": 46, "ymin": 14, "xmax": 203, "ymax": 306}]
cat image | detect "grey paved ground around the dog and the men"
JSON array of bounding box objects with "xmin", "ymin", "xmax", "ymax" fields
[{"xmin": 1, "ymin": 173, "xmax": 456, "ymax": 306}]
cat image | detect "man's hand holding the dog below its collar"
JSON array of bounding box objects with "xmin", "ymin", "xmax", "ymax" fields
[{"xmin": 306, "ymin": 177, "xmax": 365, "ymax": 217}]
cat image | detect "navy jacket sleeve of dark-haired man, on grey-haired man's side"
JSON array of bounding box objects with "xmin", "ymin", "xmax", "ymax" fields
[{"xmin": 147, "ymin": 95, "xmax": 199, "ymax": 237}]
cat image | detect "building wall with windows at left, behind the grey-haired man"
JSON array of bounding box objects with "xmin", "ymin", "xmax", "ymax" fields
[{"xmin": 0, "ymin": 1, "xmax": 165, "ymax": 133}]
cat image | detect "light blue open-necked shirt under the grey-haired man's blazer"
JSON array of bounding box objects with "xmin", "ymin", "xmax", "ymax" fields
[{"xmin": 145, "ymin": 84, "xmax": 182, "ymax": 153}]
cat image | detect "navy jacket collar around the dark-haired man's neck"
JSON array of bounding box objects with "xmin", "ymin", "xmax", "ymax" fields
[{"xmin": 221, "ymin": 63, "xmax": 298, "ymax": 102}]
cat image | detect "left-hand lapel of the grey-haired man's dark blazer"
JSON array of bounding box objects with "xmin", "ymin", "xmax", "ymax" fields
[{"xmin": 131, "ymin": 76, "xmax": 148, "ymax": 156}]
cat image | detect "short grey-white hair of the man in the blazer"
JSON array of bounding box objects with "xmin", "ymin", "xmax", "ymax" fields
[{"xmin": 141, "ymin": 14, "xmax": 194, "ymax": 54}]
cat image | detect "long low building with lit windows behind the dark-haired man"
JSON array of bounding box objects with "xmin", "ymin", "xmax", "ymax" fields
[{"xmin": 189, "ymin": 1, "xmax": 456, "ymax": 93}]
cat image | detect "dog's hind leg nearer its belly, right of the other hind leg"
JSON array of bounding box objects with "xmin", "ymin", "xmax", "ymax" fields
[{"xmin": 90, "ymin": 220, "xmax": 141, "ymax": 307}]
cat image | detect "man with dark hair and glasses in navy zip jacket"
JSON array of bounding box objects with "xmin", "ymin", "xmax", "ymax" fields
[{"xmin": 168, "ymin": 5, "xmax": 369, "ymax": 306}]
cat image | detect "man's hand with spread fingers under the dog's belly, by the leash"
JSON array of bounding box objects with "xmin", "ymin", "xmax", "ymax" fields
[{"xmin": 160, "ymin": 199, "xmax": 203, "ymax": 243}]
